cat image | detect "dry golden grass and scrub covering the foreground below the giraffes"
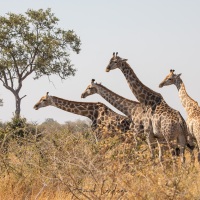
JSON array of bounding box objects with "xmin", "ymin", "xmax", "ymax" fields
[{"xmin": 0, "ymin": 121, "xmax": 200, "ymax": 200}]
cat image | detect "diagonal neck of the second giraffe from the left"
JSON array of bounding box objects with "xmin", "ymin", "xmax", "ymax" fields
[{"xmin": 95, "ymin": 84, "xmax": 139, "ymax": 117}]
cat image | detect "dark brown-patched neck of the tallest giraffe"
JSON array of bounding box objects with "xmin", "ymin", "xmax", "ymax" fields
[{"xmin": 119, "ymin": 63, "xmax": 164, "ymax": 106}]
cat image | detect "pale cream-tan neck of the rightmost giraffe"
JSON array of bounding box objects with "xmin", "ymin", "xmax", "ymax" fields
[{"xmin": 175, "ymin": 78, "xmax": 198, "ymax": 116}]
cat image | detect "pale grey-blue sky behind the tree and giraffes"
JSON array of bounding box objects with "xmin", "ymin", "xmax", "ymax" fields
[{"xmin": 0, "ymin": 0, "xmax": 200, "ymax": 123}]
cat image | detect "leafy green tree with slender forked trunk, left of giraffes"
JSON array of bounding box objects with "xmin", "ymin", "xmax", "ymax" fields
[{"xmin": 0, "ymin": 9, "xmax": 81, "ymax": 117}]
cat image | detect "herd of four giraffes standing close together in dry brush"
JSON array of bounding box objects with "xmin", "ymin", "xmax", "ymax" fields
[{"xmin": 34, "ymin": 53, "xmax": 200, "ymax": 163}]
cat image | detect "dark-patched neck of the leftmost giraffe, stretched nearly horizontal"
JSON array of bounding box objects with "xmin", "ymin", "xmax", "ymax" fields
[{"xmin": 50, "ymin": 96, "xmax": 98, "ymax": 121}]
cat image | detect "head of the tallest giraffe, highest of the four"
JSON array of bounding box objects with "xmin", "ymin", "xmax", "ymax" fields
[{"xmin": 106, "ymin": 52, "xmax": 128, "ymax": 72}]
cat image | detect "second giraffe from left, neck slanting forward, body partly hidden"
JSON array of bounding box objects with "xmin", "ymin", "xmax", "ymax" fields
[{"xmin": 81, "ymin": 79, "xmax": 145, "ymax": 137}]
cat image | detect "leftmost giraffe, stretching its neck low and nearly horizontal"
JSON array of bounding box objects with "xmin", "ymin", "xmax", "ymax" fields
[{"xmin": 33, "ymin": 92, "xmax": 131, "ymax": 140}]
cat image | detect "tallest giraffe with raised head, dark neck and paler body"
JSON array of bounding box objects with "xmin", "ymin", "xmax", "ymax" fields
[{"xmin": 106, "ymin": 53, "xmax": 193, "ymax": 163}]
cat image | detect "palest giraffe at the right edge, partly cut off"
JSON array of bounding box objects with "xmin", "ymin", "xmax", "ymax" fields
[{"xmin": 159, "ymin": 69, "xmax": 200, "ymax": 163}]
